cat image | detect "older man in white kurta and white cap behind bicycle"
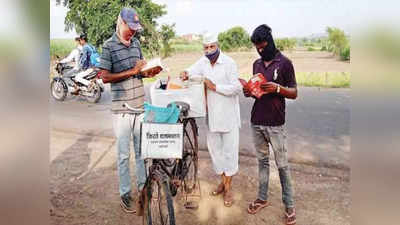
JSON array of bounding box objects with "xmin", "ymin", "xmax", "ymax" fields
[{"xmin": 181, "ymin": 33, "xmax": 242, "ymax": 207}]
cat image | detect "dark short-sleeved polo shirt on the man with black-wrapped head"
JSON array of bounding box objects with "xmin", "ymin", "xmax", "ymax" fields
[{"xmin": 251, "ymin": 51, "xmax": 297, "ymax": 126}]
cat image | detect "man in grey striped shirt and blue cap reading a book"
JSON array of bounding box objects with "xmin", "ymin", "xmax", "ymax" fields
[{"xmin": 99, "ymin": 8, "xmax": 160, "ymax": 213}]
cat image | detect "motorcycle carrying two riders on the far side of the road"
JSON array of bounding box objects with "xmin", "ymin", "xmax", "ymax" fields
[{"xmin": 50, "ymin": 58, "xmax": 104, "ymax": 103}]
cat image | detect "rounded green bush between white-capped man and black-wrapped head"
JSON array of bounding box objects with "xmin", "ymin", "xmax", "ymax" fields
[{"xmin": 218, "ymin": 27, "xmax": 252, "ymax": 51}]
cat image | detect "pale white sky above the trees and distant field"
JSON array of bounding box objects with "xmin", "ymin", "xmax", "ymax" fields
[{"xmin": 50, "ymin": 0, "xmax": 399, "ymax": 38}]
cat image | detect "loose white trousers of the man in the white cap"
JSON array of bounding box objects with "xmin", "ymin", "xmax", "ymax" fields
[{"xmin": 207, "ymin": 127, "xmax": 239, "ymax": 176}]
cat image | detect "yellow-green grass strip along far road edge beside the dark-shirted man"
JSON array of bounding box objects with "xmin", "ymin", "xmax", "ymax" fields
[{"xmin": 240, "ymin": 72, "xmax": 351, "ymax": 88}]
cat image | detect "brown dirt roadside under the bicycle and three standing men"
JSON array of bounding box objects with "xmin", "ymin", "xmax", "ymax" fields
[{"xmin": 50, "ymin": 131, "xmax": 350, "ymax": 225}]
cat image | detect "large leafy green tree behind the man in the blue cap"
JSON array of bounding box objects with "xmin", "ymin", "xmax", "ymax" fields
[{"xmin": 57, "ymin": 0, "xmax": 173, "ymax": 55}]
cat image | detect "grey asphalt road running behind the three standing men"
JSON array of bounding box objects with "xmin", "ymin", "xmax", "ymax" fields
[{"xmin": 50, "ymin": 84, "xmax": 350, "ymax": 169}]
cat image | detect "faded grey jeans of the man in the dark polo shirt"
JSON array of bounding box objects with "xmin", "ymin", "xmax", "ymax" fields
[{"xmin": 252, "ymin": 125, "xmax": 294, "ymax": 208}]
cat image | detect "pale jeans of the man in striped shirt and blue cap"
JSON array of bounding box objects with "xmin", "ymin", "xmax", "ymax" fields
[{"xmin": 112, "ymin": 113, "xmax": 146, "ymax": 196}]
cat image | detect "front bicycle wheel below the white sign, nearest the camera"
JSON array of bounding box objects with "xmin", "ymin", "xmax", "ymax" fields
[{"xmin": 143, "ymin": 180, "xmax": 175, "ymax": 225}]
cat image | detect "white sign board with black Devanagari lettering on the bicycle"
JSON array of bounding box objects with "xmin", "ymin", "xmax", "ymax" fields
[{"xmin": 140, "ymin": 122, "xmax": 183, "ymax": 159}]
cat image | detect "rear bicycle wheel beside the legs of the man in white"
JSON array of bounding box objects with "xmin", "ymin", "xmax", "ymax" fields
[{"xmin": 182, "ymin": 118, "xmax": 198, "ymax": 194}]
